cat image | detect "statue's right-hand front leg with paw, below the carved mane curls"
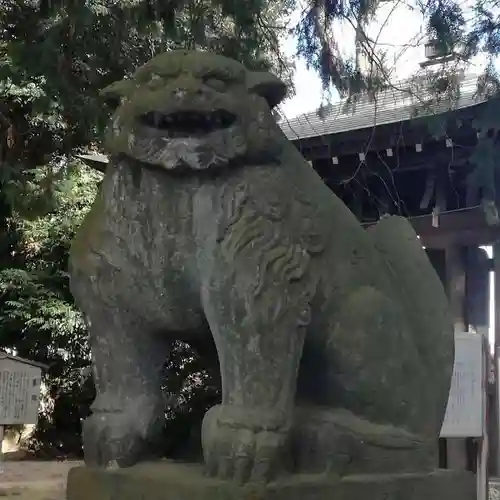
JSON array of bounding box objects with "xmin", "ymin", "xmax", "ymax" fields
[{"xmin": 202, "ymin": 273, "xmax": 307, "ymax": 482}]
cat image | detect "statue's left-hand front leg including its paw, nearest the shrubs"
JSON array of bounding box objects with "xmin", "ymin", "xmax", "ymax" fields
[{"xmin": 71, "ymin": 266, "xmax": 168, "ymax": 467}]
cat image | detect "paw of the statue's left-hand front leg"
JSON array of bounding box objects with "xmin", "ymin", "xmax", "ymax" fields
[{"xmin": 83, "ymin": 394, "xmax": 164, "ymax": 467}]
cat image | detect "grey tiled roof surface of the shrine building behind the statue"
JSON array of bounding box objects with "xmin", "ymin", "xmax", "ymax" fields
[{"xmin": 280, "ymin": 71, "xmax": 485, "ymax": 141}]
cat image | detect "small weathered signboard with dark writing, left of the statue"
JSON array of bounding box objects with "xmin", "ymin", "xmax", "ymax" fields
[{"xmin": 0, "ymin": 355, "xmax": 42, "ymax": 426}]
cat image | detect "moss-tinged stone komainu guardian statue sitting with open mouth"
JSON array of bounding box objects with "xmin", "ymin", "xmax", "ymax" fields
[{"xmin": 70, "ymin": 51, "xmax": 453, "ymax": 482}]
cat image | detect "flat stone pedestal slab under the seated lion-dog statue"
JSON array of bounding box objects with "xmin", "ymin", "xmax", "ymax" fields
[{"xmin": 67, "ymin": 461, "xmax": 476, "ymax": 500}]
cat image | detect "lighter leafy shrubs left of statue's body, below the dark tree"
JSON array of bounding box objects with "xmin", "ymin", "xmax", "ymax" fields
[{"xmin": 0, "ymin": 167, "xmax": 100, "ymax": 453}]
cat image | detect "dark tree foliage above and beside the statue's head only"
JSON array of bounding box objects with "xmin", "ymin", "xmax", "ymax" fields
[{"xmin": 0, "ymin": 0, "xmax": 293, "ymax": 182}]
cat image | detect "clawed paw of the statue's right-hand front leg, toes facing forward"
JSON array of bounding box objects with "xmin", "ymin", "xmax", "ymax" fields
[{"xmin": 202, "ymin": 405, "xmax": 289, "ymax": 484}]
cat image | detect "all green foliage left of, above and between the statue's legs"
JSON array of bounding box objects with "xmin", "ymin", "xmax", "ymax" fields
[{"xmin": 0, "ymin": 0, "xmax": 295, "ymax": 453}]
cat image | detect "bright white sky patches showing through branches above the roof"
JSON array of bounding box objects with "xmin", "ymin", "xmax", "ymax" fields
[{"xmin": 281, "ymin": 0, "xmax": 485, "ymax": 119}]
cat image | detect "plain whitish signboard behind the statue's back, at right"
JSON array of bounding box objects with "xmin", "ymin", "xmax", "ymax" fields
[{"xmin": 440, "ymin": 333, "xmax": 487, "ymax": 438}]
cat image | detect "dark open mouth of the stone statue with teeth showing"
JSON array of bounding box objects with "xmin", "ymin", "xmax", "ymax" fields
[{"xmin": 141, "ymin": 109, "xmax": 236, "ymax": 137}]
